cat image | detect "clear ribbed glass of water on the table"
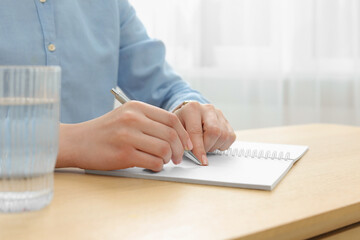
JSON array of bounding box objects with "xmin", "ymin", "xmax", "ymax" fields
[{"xmin": 0, "ymin": 66, "xmax": 61, "ymax": 212}]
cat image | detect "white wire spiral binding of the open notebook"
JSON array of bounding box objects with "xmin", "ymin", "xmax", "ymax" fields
[{"xmin": 210, "ymin": 148, "xmax": 290, "ymax": 161}]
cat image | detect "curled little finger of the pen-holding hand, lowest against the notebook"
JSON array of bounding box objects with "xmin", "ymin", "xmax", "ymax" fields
[{"xmin": 129, "ymin": 150, "xmax": 164, "ymax": 172}]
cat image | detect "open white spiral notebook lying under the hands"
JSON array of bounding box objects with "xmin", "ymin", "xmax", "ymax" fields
[{"xmin": 86, "ymin": 141, "xmax": 308, "ymax": 190}]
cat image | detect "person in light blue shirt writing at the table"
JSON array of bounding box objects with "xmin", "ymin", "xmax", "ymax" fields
[{"xmin": 0, "ymin": 0, "xmax": 235, "ymax": 171}]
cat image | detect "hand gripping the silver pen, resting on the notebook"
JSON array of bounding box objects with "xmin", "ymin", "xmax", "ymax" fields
[{"xmin": 56, "ymin": 101, "xmax": 193, "ymax": 171}]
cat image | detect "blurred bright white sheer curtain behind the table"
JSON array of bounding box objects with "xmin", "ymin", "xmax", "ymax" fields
[{"xmin": 130, "ymin": 0, "xmax": 360, "ymax": 130}]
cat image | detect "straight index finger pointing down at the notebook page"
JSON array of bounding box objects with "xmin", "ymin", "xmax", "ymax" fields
[{"xmin": 177, "ymin": 102, "xmax": 208, "ymax": 165}]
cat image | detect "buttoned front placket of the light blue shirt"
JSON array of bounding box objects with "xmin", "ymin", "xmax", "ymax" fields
[{"xmin": 34, "ymin": 0, "xmax": 59, "ymax": 65}]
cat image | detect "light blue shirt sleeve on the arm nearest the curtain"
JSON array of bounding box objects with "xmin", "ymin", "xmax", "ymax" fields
[{"xmin": 118, "ymin": 0, "xmax": 208, "ymax": 110}]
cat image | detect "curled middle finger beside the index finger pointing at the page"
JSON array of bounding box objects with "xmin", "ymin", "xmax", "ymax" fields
[{"xmin": 202, "ymin": 108, "xmax": 221, "ymax": 152}]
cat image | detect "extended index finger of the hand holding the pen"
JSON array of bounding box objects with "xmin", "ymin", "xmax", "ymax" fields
[{"xmin": 134, "ymin": 103, "xmax": 193, "ymax": 150}]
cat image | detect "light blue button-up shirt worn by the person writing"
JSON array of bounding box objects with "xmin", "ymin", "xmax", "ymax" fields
[{"xmin": 0, "ymin": 0, "xmax": 207, "ymax": 123}]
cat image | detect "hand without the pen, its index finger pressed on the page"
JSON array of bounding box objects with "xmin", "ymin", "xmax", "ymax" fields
[{"xmin": 175, "ymin": 102, "xmax": 236, "ymax": 165}]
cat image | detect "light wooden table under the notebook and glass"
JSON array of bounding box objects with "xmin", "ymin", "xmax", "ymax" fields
[{"xmin": 0, "ymin": 124, "xmax": 360, "ymax": 239}]
